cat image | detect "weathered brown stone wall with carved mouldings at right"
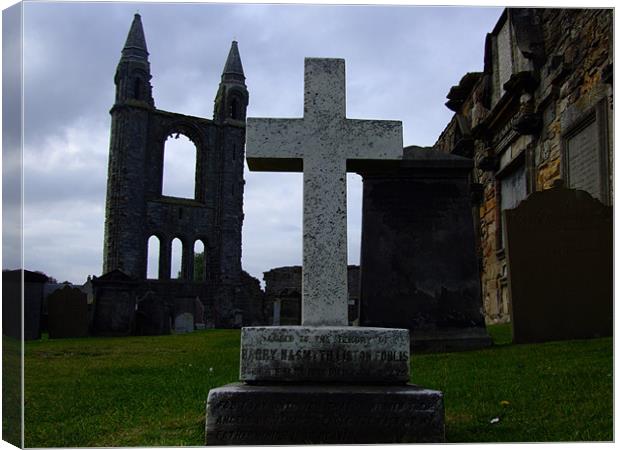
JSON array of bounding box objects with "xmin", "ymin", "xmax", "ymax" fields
[{"xmin": 434, "ymin": 8, "xmax": 613, "ymax": 323}]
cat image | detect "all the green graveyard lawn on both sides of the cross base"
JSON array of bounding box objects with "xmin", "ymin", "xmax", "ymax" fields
[{"xmin": 21, "ymin": 325, "xmax": 613, "ymax": 447}]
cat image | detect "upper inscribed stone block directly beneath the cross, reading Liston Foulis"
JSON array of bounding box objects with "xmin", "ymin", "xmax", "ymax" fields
[{"xmin": 239, "ymin": 326, "xmax": 409, "ymax": 383}]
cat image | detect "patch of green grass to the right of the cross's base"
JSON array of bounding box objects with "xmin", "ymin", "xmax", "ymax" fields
[{"xmin": 411, "ymin": 325, "xmax": 613, "ymax": 442}]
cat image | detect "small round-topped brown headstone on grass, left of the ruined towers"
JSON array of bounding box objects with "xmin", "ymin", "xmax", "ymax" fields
[{"xmin": 47, "ymin": 286, "xmax": 88, "ymax": 339}]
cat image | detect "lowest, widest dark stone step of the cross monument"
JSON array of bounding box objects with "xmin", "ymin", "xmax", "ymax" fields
[{"xmin": 206, "ymin": 383, "xmax": 445, "ymax": 445}]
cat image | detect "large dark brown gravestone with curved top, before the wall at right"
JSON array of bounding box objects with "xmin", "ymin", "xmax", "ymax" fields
[{"xmin": 505, "ymin": 187, "xmax": 613, "ymax": 343}]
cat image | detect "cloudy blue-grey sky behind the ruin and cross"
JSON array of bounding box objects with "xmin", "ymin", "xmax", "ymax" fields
[{"xmin": 3, "ymin": 2, "xmax": 501, "ymax": 283}]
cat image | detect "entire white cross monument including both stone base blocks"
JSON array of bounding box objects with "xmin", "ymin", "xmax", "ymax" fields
[{"xmin": 206, "ymin": 58, "xmax": 444, "ymax": 445}]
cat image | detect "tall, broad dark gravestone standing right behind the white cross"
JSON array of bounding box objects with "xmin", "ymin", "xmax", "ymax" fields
[{"xmin": 360, "ymin": 147, "xmax": 491, "ymax": 351}]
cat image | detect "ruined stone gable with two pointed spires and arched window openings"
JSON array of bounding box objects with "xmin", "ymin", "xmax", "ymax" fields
[{"xmin": 103, "ymin": 14, "xmax": 249, "ymax": 325}]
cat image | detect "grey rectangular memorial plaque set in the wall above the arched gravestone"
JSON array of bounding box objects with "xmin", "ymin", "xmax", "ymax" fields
[{"xmin": 566, "ymin": 120, "xmax": 604, "ymax": 201}]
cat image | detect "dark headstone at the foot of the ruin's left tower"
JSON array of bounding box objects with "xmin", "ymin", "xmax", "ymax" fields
[{"xmin": 92, "ymin": 270, "xmax": 136, "ymax": 336}]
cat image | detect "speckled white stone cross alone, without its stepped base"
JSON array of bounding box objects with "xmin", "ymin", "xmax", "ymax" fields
[{"xmin": 246, "ymin": 58, "xmax": 403, "ymax": 326}]
